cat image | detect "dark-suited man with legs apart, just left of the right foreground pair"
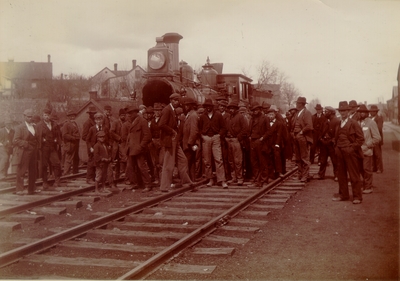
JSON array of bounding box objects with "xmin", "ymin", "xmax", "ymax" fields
[{"xmin": 313, "ymin": 106, "xmax": 340, "ymax": 181}]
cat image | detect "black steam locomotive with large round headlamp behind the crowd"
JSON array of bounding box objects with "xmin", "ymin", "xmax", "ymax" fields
[{"xmin": 142, "ymin": 33, "xmax": 252, "ymax": 106}]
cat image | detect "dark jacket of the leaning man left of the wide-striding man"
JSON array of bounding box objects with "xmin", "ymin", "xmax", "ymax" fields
[{"xmin": 126, "ymin": 116, "xmax": 151, "ymax": 156}]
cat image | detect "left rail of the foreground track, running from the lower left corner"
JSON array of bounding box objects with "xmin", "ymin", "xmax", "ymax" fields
[{"xmin": 0, "ymin": 180, "xmax": 205, "ymax": 268}]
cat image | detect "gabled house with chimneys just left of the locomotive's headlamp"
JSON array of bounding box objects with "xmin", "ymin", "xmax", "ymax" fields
[{"xmin": 90, "ymin": 60, "xmax": 146, "ymax": 99}]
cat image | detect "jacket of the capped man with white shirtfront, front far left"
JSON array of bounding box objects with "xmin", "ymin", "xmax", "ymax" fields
[{"xmin": 11, "ymin": 122, "xmax": 39, "ymax": 165}]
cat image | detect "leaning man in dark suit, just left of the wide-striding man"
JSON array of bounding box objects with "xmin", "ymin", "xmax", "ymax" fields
[{"xmin": 126, "ymin": 106, "xmax": 152, "ymax": 192}]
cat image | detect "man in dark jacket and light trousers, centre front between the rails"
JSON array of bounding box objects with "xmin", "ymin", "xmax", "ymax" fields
[{"xmin": 199, "ymin": 98, "xmax": 228, "ymax": 188}]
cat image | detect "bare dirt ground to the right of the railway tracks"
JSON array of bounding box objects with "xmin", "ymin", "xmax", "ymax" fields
[{"xmin": 183, "ymin": 125, "xmax": 400, "ymax": 280}]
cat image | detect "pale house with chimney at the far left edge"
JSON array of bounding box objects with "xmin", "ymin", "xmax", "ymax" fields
[{"xmin": 0, "ymin": 55, "xmax": 53, "ymax": 98}]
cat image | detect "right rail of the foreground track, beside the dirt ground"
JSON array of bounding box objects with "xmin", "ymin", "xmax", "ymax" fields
[{"xmin": 117, "ymin": 167, "xmax": 298, "ymax": 280}]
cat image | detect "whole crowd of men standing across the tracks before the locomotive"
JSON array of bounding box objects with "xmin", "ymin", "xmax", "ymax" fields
[{"xmin": 0, "ymin": 94, "xmax": 383, "ymax": 204}]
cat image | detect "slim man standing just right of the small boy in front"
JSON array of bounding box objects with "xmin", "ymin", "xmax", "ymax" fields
[{"xmin": 110, "ymin": 108, "xmax": 126, "ymax": 179}]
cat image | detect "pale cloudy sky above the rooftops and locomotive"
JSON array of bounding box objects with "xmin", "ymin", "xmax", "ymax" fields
[{"xmin": 0, "ymin": 0, "xmax": 400, "ymax": 107}]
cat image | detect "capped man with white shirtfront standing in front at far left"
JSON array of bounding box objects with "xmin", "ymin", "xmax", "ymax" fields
[{"xmin": 12, "ymin": 109, "xmax": 39, "ymax": 195}]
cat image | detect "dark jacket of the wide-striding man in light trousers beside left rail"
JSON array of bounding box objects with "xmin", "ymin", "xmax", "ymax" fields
[{"xmin": 158, "ymin": 104, "xmax": 178, "ymax": 147}]
